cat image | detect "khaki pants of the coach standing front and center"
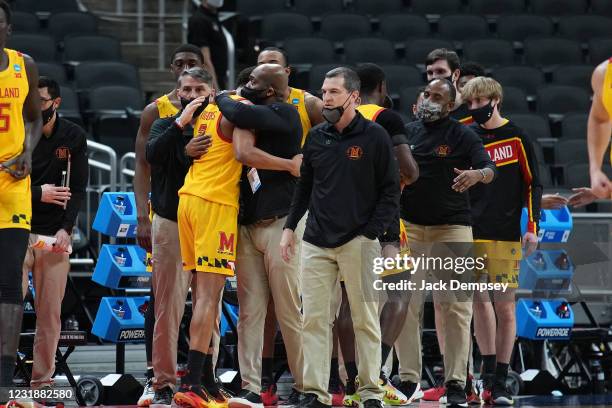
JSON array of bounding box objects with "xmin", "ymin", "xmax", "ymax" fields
[{"xmin": 301, "ymin": 236, "xmax": 384, "ymax": 405}]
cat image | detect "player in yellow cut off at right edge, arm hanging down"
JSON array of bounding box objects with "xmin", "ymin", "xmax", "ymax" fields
[{"xmin": 569, "ymin": 58, "xmax": 612, "ymax": 207}]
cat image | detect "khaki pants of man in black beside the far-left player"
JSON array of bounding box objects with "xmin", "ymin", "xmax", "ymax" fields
[{"xmin": 23, "ymin": 234, "xmax": 70, "ymax": 387}]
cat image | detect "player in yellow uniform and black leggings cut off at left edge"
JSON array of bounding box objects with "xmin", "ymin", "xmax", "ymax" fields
[{"xmin": 0, "ymin": 0, "xmax": 42, "ymax": 387}]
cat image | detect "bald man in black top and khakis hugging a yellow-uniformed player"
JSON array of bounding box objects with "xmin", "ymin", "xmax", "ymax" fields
[{"xmin": 216, "ymin": 64, "xmax": 303, "ymax": 407}]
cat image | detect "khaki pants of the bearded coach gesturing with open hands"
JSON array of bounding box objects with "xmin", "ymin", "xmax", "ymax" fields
[{"xmin": 395, "ymin": 221, "xmax": 473, "ymax": 384}]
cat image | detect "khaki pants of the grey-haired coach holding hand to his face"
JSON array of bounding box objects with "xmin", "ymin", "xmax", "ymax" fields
[{"xmin": 151, "ymin": 214, "xmax": 191, "ymax": 389}]
